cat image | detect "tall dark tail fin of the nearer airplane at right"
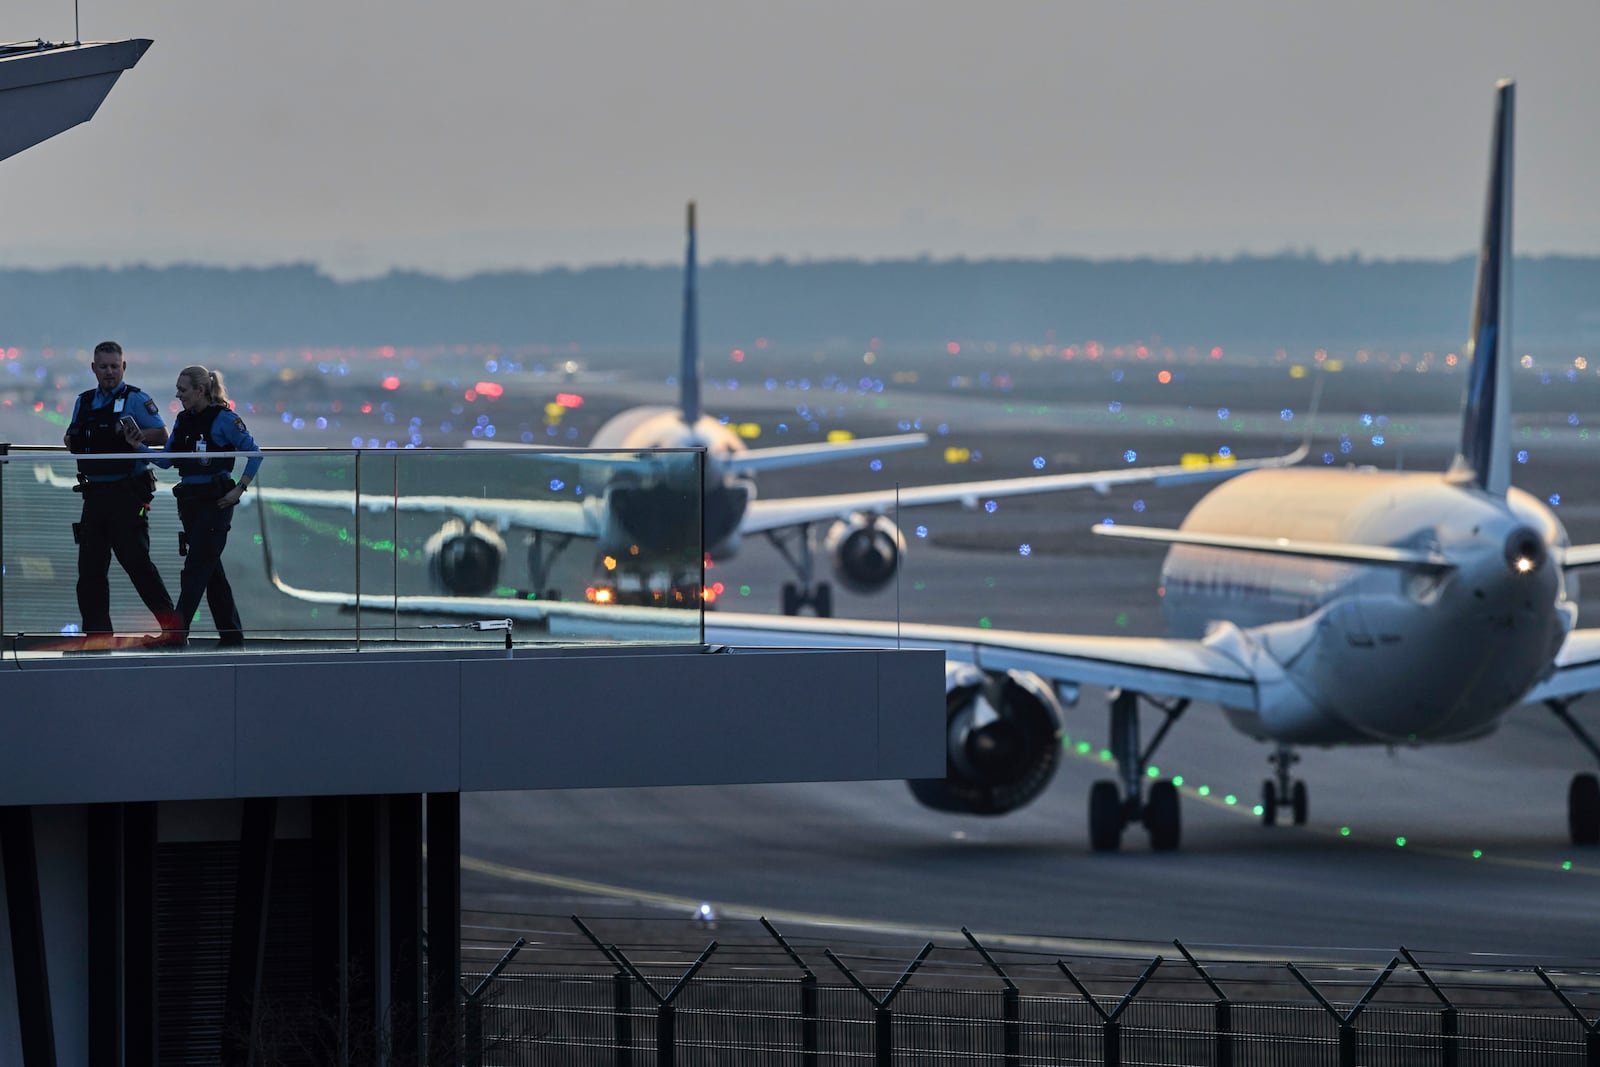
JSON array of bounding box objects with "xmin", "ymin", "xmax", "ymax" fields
[{"xmin": 1451, "ymin": 80, "xmax": 1517, "ymax": 496}]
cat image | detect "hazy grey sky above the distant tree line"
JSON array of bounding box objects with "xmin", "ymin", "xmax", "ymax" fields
[{"xmin": 9, "ymin": 0, "xmax": 1600, "ymax": 277}]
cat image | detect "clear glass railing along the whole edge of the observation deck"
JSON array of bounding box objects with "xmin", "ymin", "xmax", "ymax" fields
[{"xmin": 0, "ymin": 448, "xmax": 706, "ymax": 656}]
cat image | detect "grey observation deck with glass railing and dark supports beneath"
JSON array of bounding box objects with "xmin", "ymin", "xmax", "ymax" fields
[{"xmin": 0, "ymin": 445, "xmax": 946, "ymax": 1065}]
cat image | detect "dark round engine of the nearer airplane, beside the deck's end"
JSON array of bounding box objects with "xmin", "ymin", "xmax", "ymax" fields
[{"xmin": 906, "ymin": 662, "xmax": 1062, "ymax": 816}]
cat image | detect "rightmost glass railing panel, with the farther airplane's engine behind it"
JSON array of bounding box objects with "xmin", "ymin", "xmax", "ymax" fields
[{"xmin": 377, "ymin": 450, "xmax": 706, "ymax": 645}]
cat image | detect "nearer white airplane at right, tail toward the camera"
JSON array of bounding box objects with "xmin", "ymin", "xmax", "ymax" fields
[{"xmin": 706, "ymin": 82, "xmax": 1600, "ymax": 851}]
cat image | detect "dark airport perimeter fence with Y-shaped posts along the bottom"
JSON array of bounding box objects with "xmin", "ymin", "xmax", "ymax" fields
[{"xmin": 464, "ymin": 917, "xmax": 1600, "ymax": 1067}]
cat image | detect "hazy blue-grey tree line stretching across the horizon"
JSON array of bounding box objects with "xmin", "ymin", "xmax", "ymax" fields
[{"xmin": 0, "ymin": 253, "xmax": 1600, "ymax": 349}]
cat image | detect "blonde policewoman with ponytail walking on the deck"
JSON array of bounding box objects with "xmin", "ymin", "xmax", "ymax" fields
[{"xmin": 128, "ymin": 366, "xmax": 261, "ymax": 648}]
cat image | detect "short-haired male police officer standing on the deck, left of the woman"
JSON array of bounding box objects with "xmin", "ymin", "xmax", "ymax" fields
[{"xmin": 62, "ymin": 341, "xmax": 178, "ymax": 635}]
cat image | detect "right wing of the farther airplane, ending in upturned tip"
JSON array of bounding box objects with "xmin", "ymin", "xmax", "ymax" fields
[{"xmin": 739, "ymin": 445, "xmax": 1307, "ymax": 533}]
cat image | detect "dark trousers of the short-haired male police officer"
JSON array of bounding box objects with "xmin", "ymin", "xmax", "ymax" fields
[{"xmin": 72, "ymin": 475, "xmax": 176, "ymax": 633}]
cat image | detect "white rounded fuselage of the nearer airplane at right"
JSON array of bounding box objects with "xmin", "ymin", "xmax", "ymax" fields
[{"xmin": 1162, "ymin": 470, "xmax": 1578, "ymax": 744}]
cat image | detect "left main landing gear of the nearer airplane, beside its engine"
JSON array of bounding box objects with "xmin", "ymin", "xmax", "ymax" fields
[{"xmin": 1090, "ymin": 689, "xmax": 1189, "ymax": 853}]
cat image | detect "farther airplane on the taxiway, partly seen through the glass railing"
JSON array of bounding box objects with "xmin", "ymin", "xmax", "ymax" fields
[{"xmin": 181, "ymin": 203, "xmax": 1306, "ymax": 619}]
